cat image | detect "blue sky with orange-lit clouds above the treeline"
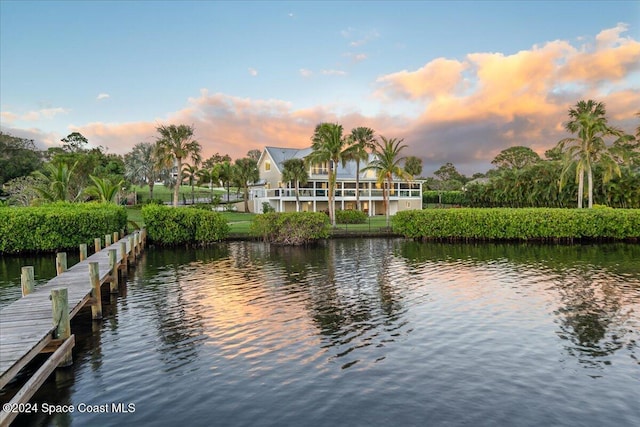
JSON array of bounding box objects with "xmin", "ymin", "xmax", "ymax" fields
[{"xmin": 0, "ymin": 0, "xmax": 640, "ymax": 176}]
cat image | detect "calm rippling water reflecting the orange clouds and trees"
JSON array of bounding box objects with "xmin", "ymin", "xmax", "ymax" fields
[{"xmin": 0, "ymin": 239, "xmax": 640, "ymax": 426}]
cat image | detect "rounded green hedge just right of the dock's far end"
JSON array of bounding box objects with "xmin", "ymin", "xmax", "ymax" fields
[{"xmin": 142, "ymin": 205, "xmax": 229, "ymax": 246}]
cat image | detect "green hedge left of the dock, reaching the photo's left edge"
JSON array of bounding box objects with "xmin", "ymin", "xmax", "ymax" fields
[{"xmin": 0, "ymin": 203, "xmax": 127, "ymax": 254}]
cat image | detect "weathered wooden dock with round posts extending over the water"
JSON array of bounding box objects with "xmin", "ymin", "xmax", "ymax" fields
[{"xmin": 0, "ymin": 230, "xmax": 145, "ymax": 427}]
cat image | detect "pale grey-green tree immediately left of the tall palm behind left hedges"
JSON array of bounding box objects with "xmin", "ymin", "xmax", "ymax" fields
[{"xmin": 124, "ymin": 142, "xmax": 169, "ymax": 199}]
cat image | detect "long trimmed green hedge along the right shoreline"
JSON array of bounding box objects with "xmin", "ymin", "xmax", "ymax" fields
[{"xmin": 393, "ymin": 208, "xmax": 640, "ymax": 240}]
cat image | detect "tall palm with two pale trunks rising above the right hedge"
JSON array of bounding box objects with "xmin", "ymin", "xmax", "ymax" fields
[{"xmin": 558, "ymin": 99, "xmax": 623, "ymax": 208}]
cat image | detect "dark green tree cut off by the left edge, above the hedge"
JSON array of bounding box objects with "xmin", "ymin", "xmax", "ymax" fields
[{"xmin": 0, "ymin": 132, "xmax": 42, "ymax": 188}]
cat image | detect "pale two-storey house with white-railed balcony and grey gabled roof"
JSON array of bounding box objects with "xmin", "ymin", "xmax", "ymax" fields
[{"xmin": 250, "ymin": 147, "xmax": 422, "ymax": 216}]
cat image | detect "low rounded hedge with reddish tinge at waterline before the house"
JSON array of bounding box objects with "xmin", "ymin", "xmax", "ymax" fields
[{"xmin": 251, "ymin": 212, "xmax": 329, "ymax": 245}]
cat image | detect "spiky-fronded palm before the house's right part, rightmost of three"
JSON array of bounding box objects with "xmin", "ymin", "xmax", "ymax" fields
[{"xmin": 364, "ymin": 136, "xmax": 413, "ymax": 227}]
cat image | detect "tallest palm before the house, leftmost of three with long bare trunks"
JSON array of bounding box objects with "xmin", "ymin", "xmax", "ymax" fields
[{"xmin": 306, "ymin": 123, "xmax": 347, "ymax": 227}]
